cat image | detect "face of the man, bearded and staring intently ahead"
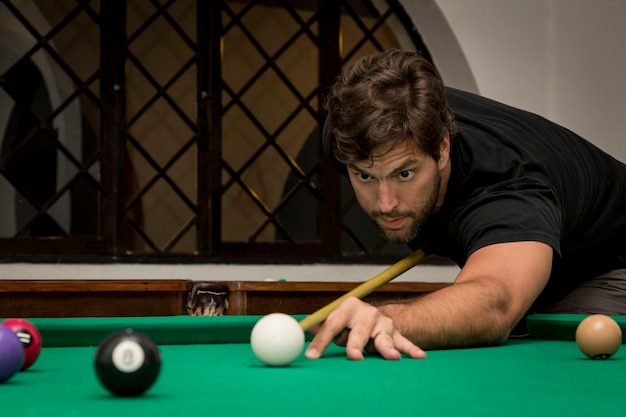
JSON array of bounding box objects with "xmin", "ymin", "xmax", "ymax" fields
[{"xmin": 348, "ymin": 137, "xmax": 449, "ymax": 243}]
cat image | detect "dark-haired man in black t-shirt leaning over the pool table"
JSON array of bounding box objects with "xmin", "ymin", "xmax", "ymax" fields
[{"xmin": 306, "ymin": 51, "xmax": 626, "ymax": 360}]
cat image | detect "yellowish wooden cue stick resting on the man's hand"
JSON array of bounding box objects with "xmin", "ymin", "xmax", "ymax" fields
[{"xmin": 300, "ymin": 250, "xmax": 428, "ymax": 331}]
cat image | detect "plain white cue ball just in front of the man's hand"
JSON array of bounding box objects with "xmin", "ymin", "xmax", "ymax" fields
[{"xmin": 250, "ymin": 313, "xmax": 304, "ymax": 366}]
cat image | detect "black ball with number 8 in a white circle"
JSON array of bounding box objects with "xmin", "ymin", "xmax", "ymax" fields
[{"xmin": 94, "ymin": 329, "xmax": 161, "ymax": 397}]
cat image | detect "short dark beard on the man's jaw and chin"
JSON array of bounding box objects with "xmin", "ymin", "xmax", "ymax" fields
[{"xmin": 370, "ymin": 175, "xmax": 441, "ymax": 244}]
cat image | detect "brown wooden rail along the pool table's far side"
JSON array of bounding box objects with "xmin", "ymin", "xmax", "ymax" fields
[{"xmin": 0, "ymin": 279, "xmax": 449, "ymax": 318}]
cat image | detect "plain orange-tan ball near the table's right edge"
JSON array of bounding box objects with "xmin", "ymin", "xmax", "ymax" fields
[{"xmin": 576, "ymin": 314, "xmax": 622, "ymax": 359}]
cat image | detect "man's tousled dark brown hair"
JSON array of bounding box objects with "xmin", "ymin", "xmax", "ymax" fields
[{"xmin": 325, "ymin": 50, "xmax": 457, "ymax": 165}]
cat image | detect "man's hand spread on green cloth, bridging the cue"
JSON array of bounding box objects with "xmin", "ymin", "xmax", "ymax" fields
[{"xmin": 305, "ymin": 297, "xmax": 426, "ymax": 360}]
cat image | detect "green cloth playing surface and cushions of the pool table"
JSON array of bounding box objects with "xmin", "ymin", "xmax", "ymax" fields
[{"xmin": 0, "ymin": 315, "xmax": 626, "ymax": 417}]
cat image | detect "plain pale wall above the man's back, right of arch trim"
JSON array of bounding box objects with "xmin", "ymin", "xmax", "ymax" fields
[{"xmin": 432, "ymin": 0, "xmax": 626, "ymax": 161}]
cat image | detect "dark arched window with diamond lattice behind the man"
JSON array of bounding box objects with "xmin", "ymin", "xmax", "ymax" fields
[{"xmin": 0, "ymin": 0, "xmax": 428, "ymax": 260}]
